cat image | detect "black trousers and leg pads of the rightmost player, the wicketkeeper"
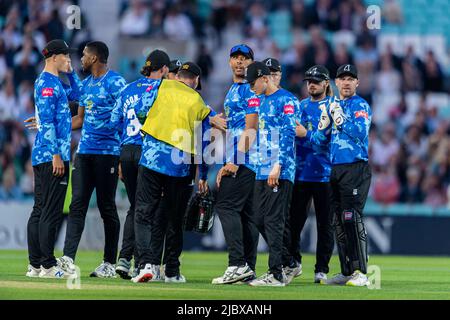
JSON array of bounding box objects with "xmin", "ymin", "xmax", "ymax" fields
[{"xmin": 330, "ymin": 161, "xmax": 372, "ymax": 276}]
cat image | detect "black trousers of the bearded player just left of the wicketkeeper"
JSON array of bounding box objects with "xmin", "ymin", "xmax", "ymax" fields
[{"xmin": 283, "ymin": 181, "xmax": 334, "ymax": 273}]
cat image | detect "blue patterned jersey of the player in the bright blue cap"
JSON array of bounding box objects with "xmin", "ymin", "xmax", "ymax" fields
[{"xmin": 223, "ymin": 83, "xmax": 262, "ymax": 171}]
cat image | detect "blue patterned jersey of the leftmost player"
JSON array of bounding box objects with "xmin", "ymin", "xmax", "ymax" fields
[{"xmin": 31, "ymin": 71, "xmax": 72, "ymax": 166}]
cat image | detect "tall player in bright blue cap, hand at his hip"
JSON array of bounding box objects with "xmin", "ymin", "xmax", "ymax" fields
[{"xmin": 212, "ymin": 44, "xmax": 260, "ymax": 284}]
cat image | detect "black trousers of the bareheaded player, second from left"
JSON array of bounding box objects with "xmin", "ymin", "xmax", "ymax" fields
[{"xmin": 64, "ymin": 154, "xmax": 120, "ymax": 264}]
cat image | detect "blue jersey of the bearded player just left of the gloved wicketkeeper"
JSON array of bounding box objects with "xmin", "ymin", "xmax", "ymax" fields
[{"xmin": 295, "ymin": 97, "xmax": 331, "ymax": 182}]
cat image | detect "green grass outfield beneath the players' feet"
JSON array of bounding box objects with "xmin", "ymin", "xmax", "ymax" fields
[{"xmin": 0, "ymin": 250, "xmax": 450, "ymax": 300}]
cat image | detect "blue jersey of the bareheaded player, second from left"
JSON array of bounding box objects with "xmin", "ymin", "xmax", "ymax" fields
[{"xmin": 77, "ymin": 70, "xmax": 126, "ymax": 155}]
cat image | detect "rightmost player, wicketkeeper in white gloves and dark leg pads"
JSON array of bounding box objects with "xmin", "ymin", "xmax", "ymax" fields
[{"xmin": 321, "ymin": 64, "xmax": 372, "ymax": 286}]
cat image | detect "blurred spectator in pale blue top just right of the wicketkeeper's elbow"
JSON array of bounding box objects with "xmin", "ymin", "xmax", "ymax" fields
[{"xmin": 371, "ymin": 122, "xmax": 400, "ymax": 167}]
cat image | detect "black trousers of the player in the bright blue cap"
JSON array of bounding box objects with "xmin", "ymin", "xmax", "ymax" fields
[{"xmin": 214, "ymin": 165, "xmax": 259, "ymax": 270}]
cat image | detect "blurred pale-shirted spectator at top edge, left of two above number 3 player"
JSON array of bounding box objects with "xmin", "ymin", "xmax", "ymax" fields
[{"xmin": 120, "ymin": 0, "xmax": 151, "ymax": 36}]
